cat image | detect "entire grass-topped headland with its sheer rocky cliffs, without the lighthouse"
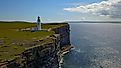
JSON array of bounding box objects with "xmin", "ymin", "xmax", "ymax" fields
[{"xmin": 0, "ymin": 23, "xmax": 71, "ymax": 68}]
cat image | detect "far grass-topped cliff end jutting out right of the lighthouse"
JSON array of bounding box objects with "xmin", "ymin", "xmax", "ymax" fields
[{"xmin": 43, "ymin": 23, "xmax": 70, "ymax": 47}]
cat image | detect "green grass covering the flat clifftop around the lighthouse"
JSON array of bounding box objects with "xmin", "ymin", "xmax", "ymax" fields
[{"xmin": 0, "ymin": 22, "xmax": 54, "ymax": 62}]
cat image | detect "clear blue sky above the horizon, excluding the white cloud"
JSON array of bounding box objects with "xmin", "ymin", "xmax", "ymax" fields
[{"xmin": 0, "ymin": 0, "xmax": 119, "ymax": 22}]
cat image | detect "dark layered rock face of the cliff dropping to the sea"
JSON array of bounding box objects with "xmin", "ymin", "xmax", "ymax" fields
[{"xmin": 0, "ymin": 23, "xmax": 70, "ymax": 68}]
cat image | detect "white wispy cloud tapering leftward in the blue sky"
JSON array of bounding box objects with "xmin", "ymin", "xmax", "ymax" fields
[{"xmin": 64, "ymin": 0, "xmax": 121, "ymax": 18}]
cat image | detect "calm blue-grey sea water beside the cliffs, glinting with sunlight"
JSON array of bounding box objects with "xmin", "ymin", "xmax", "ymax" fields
[{"xmin": 63, "ymin": 23, "xmax": 121, "ymax": 68}]
